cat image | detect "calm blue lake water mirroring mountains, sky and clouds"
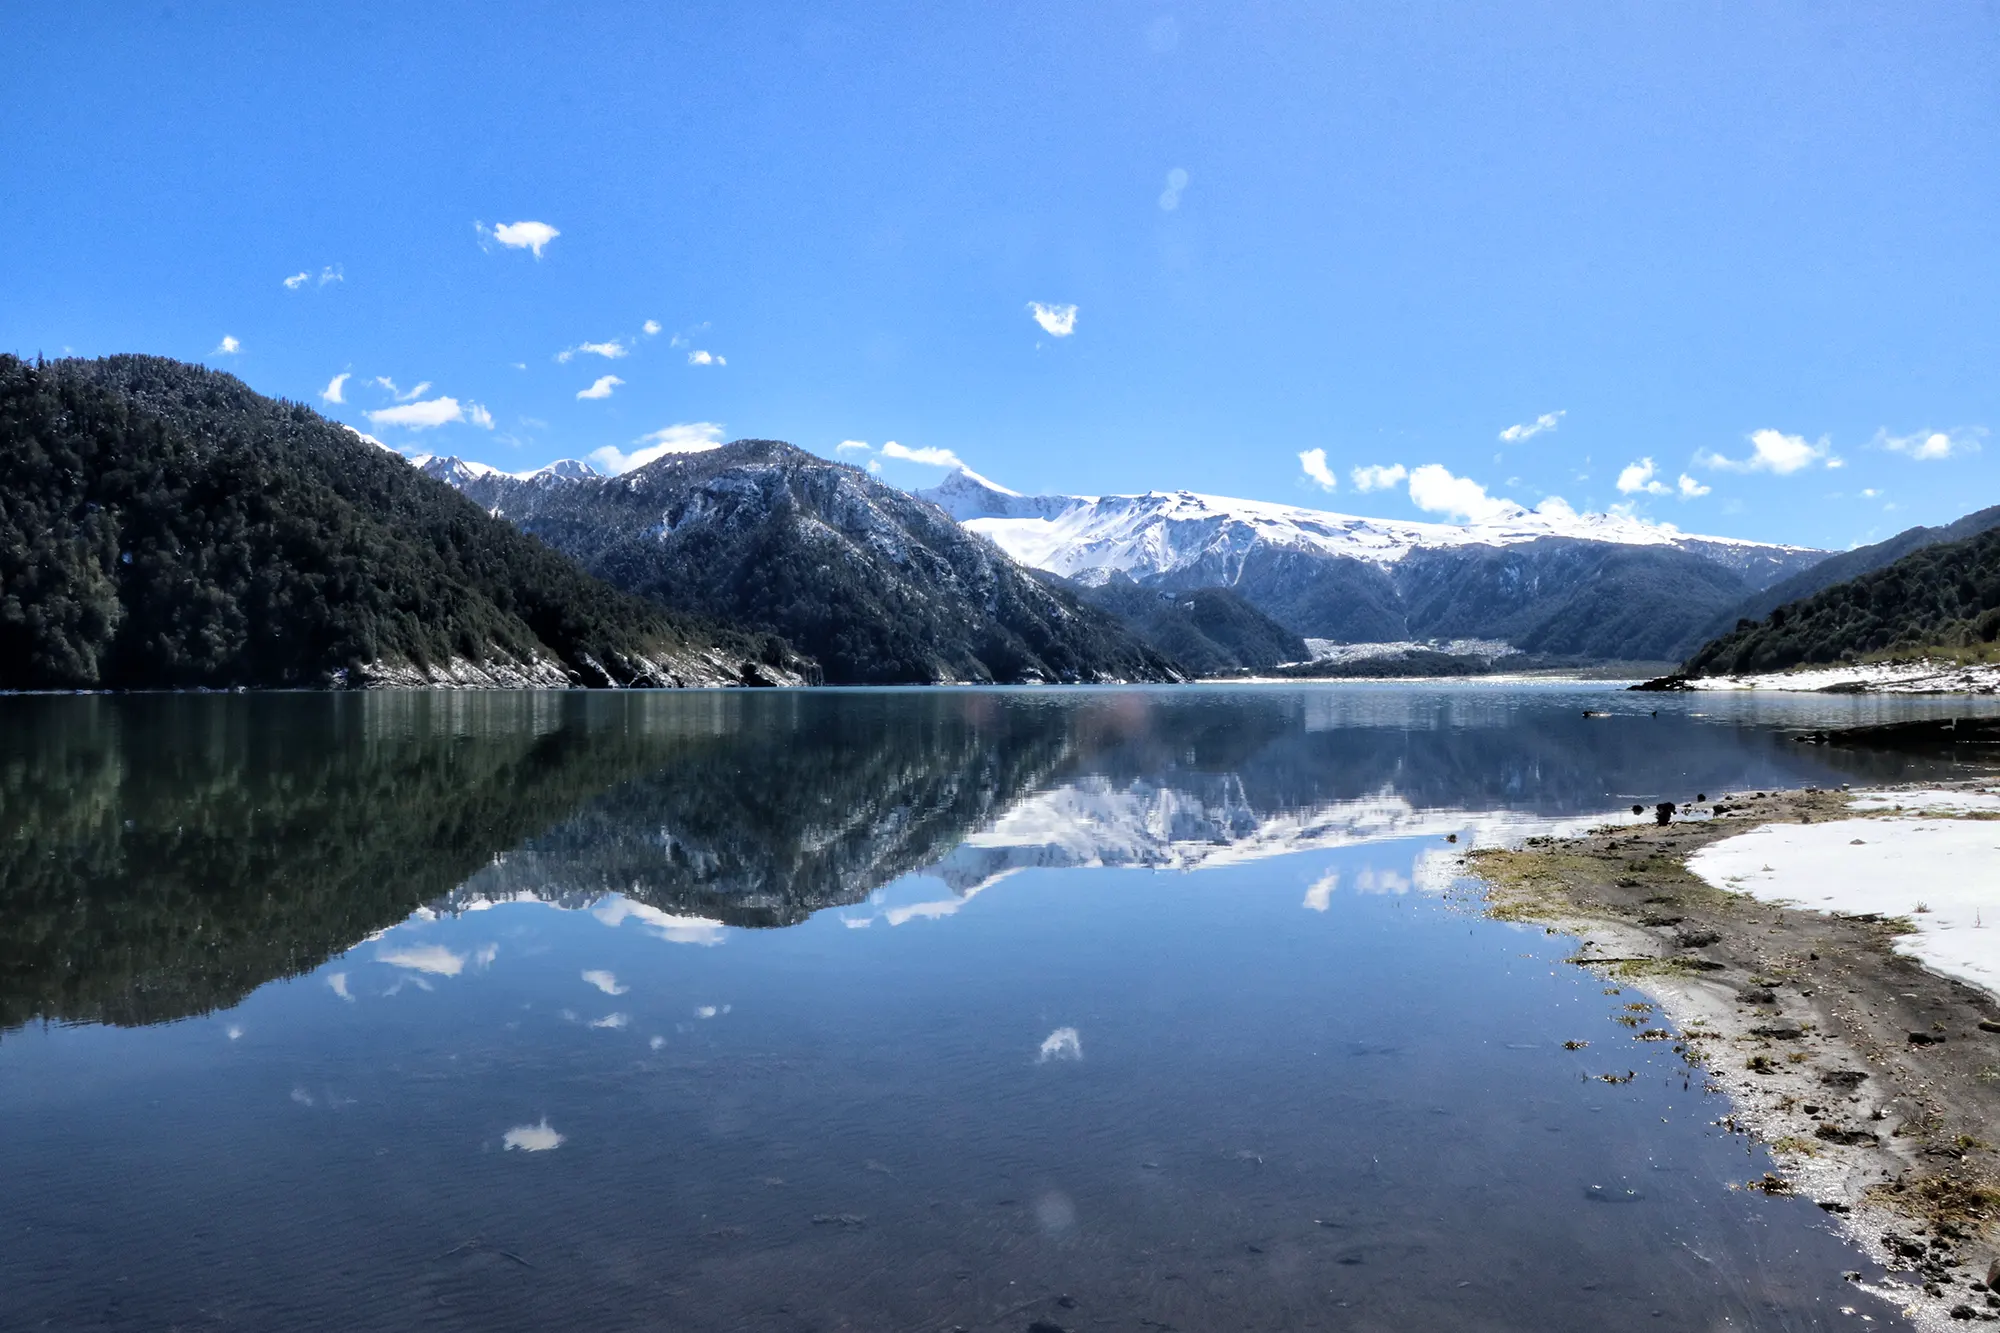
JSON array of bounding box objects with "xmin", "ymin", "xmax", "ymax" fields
[{"xmin": 0, "ymin": 685, "xmax": 1992, "ymax": 1331}]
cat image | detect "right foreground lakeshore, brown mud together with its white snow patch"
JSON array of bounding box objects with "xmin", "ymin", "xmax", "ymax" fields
[{"xmin": 1464, "ymin": 777, "xmax": 2000, "ymax": 1329}]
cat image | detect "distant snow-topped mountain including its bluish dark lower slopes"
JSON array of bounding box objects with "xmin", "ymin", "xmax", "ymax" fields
[{"xmin": 922, "ymin": 472, "xmax": 1824, "ymax": 658}]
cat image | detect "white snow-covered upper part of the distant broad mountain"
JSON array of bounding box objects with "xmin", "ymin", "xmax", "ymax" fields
[{"xmin": 918, "ymin": 470, "xmax": 1826, "ymax": 586}]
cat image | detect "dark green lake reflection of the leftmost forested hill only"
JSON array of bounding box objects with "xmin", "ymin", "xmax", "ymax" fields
[{"xmin": 0, "ymin": 695, "xmax": 688, "ymax": 1029}]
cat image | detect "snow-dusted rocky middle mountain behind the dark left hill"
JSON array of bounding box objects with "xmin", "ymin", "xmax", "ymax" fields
[{"xmin": 426, "ymin": 440, "xmax": 1178, "ymax": 685}]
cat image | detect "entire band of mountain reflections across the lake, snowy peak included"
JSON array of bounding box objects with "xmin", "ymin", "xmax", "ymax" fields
[{"xmin": 0, "ymin": 687, "xmax": 1976, "ymax": 1031}]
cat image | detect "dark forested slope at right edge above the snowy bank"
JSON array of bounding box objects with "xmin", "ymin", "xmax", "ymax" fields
[{"xmin": 1686, "ymin": 528, "xmax": 2000, "ymax": 677}]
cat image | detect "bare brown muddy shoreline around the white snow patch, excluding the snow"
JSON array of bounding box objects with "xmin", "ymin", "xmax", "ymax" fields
[{"xmin": 1460, "ymin": 779, "xmax": 2000, "ymax": 1329}]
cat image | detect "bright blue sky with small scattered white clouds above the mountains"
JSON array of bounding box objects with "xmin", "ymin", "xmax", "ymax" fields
[{"xmin": 0, "ymin": 0, "xmax": 2000, "ymax": 546}]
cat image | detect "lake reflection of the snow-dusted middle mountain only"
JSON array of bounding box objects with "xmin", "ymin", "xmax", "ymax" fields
[{"xmin": 460, "ymin": 693, "xmax": 1070, "ymax": 927}]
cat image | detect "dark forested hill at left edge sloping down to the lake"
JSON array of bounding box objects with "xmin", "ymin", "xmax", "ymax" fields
[{"xmin": 0, "ymin": 356, "xmax": 810, "ymax": 689}]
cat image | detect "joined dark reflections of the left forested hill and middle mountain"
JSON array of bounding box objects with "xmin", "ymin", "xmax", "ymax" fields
[{"xmin": 0, "ymin": 693, "xmax": 1064, "ymax": 1029}]
